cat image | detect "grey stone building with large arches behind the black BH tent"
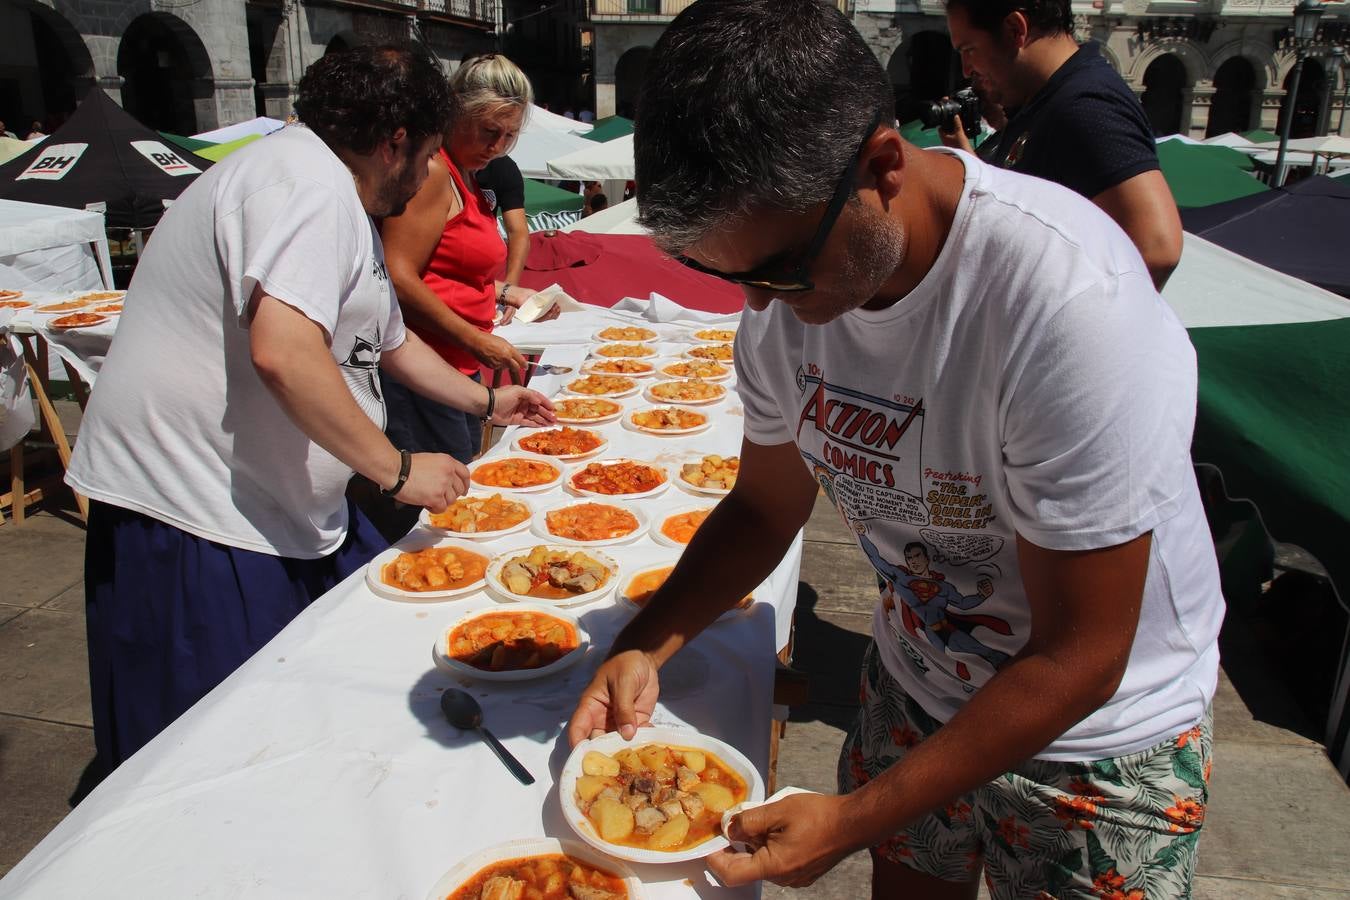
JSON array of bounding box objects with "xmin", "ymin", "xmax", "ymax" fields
[{"xmin": 0, "ymin": 0, "xmax": 500, "ymax": 134}]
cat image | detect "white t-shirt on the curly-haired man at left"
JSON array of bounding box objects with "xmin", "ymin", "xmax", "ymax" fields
[{"xmin": 66, "ymin": 127, "xmax": 404, "ymax": 559}]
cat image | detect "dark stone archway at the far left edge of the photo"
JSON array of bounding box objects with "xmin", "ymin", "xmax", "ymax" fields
[{"xmin": 0, "ymin": 0, "xmax": 93, "ymax": 138}]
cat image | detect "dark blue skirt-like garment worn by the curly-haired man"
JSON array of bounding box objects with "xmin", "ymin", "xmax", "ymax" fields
[{"xmin": 85, "ymin": 502, "xmax": 387, "ymax": 772}]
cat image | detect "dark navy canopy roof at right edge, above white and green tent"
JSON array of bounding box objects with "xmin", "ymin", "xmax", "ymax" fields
[{"xmin": 1181, "ymin": 175, "xmax": 1350, "ymax": 297}]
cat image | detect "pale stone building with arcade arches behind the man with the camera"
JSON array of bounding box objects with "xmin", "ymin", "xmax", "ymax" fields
[{"xmin": 590, "ymin": 0, "xmax": 1350, "ymax": 138}]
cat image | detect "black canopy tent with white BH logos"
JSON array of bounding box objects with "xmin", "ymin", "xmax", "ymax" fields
[{"xmin": 0, "ymin": 88, "xmax": 211, "ymax": 228}]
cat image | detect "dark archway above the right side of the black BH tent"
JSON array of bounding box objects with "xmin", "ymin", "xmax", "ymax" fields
[{"xmin": 117, "ymin": 12, "xmax": 211, "ymax": 135}]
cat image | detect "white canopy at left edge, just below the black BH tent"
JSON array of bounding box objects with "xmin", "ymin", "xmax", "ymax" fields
[{"xmin": 0, "ymin": 200, "xmax": 112, "ymax": 293}]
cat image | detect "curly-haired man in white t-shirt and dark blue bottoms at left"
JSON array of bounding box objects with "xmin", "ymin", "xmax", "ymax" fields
[{"xmin": 66, "ymin": 45, "xmax": 552, "ymax": 770}]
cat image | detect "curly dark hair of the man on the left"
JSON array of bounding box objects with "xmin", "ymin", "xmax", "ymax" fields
[{"xmin": 296, "ymin": 42, "xmax": 450, "ymax": 154}]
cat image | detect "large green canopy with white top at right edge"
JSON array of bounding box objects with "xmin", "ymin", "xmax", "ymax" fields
[{"xmin": 1162, "ymin": 233, "xmax": 1350, "ymax": 776}]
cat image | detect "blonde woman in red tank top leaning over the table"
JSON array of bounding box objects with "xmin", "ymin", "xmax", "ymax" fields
[{"xmin": 381, "ymin": 54, "xmax": 533, "ymax": 483}]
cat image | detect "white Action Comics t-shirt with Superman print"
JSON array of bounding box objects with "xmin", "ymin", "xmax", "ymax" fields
[{"xmin": 736, "ymin": 149, "xmax": 1223, "ymax": 760}]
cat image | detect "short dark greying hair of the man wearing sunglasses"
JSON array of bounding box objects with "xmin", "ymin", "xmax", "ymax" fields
[{"xmin": 635, "ymin": 0, "xmax": 895, "ymax": 251}]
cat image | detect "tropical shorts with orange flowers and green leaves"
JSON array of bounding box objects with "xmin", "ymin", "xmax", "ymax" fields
[{"xmin": 838, "ymin": 644, "xmax": 1212, "ymax": 900}]
